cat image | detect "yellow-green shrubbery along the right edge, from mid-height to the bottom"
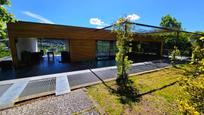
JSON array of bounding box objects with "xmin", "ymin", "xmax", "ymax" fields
[{"xmin": 178, "ymin": 37, "xmax": 204, "ymax": 115}]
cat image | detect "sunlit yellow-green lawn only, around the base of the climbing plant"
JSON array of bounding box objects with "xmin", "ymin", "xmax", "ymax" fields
[{"xmin": 87, "ymin": 65, "xmax": 194, "ymax": 115}]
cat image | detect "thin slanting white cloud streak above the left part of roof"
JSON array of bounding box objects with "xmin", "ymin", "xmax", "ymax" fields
[{"xmin": 22, "ymin": 11, "xmax": 54, "ymax": 24}]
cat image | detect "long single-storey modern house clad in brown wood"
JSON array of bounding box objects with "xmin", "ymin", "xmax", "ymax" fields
[{"xmin": 7, "ymin": 21, "xmax": 163, "ymax": 66}]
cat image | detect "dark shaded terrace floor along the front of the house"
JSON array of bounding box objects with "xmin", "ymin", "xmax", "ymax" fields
[{"xmin": 0, "ymin": 55, "xmax": 164, "ymax": 81}]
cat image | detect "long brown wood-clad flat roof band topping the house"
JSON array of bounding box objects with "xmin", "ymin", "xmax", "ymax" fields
[{"xmin": 7, "ymin": 21, "xmax": 162, "ymax": 42}]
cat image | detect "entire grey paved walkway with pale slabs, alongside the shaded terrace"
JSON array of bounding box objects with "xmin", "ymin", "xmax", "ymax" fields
[{"xmin": 0, "ymin": 60, "xmax": 169, "ymax": 109}]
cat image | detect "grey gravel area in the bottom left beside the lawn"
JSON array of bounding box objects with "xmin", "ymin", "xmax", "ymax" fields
[{"xmin": 0, "ymin": 89, "xmax": 99, "ymax": 115}]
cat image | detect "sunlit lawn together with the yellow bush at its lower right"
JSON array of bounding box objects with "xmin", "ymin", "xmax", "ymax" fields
[{"xmin": 88, "ymin": 64, "xmax": 204, "ymax": 115}]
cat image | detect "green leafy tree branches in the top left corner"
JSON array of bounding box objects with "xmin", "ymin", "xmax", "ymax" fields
[{"xmin": 0, "ymin": 0, "xmax": 15, "ymax": 38}]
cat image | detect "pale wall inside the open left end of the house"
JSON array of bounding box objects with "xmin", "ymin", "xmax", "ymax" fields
[{"xmin": 16, "ymin": 38, "xmax": 38, "ymax": 60}]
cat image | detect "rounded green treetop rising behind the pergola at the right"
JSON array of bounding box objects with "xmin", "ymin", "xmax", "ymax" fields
[{"xmin": 160, "ymin": 14, "xmax": 182, "ymax": 30}]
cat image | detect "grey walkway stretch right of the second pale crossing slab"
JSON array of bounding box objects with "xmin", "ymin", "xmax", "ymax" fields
[{"xmin": 68, "ymin": 60, "xmax": 170, "ymax": 88}]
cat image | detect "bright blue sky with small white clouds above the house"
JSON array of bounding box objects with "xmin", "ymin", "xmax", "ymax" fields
[{"xmin": 5, "ymin": 0, "xmax": 204, "ymax": 31}]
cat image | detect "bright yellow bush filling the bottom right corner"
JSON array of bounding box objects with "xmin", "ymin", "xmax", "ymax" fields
[{"xmin": 179, "ymin": 76, "xmax": 204, "ymax": 115}]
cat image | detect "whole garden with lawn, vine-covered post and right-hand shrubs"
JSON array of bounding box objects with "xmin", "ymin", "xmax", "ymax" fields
[{"xmin": 87, "ymin": 16, "xmax": 204, "ymax": 115}]
